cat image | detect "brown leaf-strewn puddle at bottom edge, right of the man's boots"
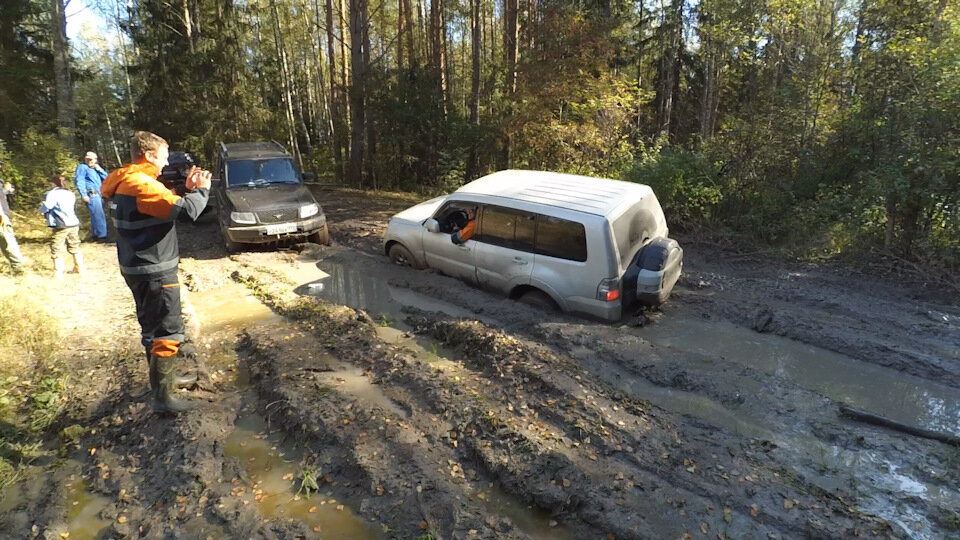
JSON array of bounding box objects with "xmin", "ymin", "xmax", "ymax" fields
[{"xmin": 225, "ymin": 400, "xmax": 378, "ymax": 540}]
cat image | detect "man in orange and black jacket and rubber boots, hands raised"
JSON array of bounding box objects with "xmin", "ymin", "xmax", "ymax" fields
[{"xmin": 101, "ymin": 131, "xmax": 210, "ymax": 413}]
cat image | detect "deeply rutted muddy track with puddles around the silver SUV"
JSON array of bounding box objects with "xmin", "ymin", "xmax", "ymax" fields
[{"xmin": 0, "ymin": 191, "xmax": 960, "ymax": 539}]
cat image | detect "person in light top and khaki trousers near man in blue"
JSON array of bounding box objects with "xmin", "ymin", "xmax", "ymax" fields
[{"xmin": 40, "ymin": 174, "xmax": 83, "ymax": 279}]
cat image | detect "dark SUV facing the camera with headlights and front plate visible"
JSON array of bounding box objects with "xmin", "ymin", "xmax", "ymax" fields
[{"xmin": 213, "ymin": 142, "xmax": 329, "ymax": 250}]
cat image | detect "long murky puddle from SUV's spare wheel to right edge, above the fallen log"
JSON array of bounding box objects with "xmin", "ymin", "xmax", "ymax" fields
[{"xmin": 641, "ymin": 318, "xmax": 960, "ymax": 434}]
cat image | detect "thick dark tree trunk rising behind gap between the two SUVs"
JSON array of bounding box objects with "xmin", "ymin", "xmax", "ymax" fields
[{"xmin": 349, "ymin": 0, "xmax": 367, "ymax": 189}]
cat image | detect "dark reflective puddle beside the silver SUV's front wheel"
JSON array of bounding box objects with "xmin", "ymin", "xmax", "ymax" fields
[{"xmin": 297, "ymin": 261, "xmax": 476, "ymax": 320}]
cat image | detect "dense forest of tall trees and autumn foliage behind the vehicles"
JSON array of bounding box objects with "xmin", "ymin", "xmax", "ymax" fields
[{"xmin": 0, "ymin": 0, "xmax": 960, "ymax": 276}]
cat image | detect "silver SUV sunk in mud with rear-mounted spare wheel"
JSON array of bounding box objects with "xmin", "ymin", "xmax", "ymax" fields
[{"xmin": 383, "ymin": 170, "xmax": 683, "ymax": 320}]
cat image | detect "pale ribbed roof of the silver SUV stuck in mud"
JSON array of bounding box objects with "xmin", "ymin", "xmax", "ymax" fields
[{"xmin": 457, "ymin": 170, "xmax": 653, "ymax": 216}]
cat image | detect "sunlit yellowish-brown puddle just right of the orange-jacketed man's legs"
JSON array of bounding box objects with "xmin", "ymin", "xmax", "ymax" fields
[{"xmin": 190, "ymin": 282, "xmax": 282, "ymax": 335}]
